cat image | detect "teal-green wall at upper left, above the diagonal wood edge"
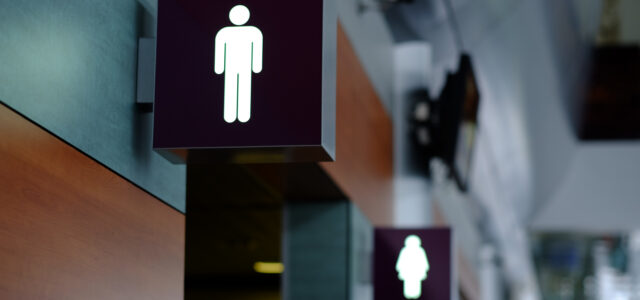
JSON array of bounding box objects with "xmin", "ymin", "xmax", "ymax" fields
[{"xmin": 0, "ymin": 0, "xmax": 186, "ymax": 212}]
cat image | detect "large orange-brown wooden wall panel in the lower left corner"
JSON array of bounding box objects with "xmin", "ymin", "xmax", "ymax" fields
[{"xmin": 0, "ymin": 104, "xmax": 185, "ymax": 299}]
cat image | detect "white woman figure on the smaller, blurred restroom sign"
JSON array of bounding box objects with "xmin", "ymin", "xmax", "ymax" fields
[{"xmin": 396, "ymin": 235, "xmax": 429, "ymax": 299}]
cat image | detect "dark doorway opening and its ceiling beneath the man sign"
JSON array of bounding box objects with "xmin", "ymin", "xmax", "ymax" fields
[{"xmin": 185, "ymin": 164, "xmax": 346, "ymax": 299}]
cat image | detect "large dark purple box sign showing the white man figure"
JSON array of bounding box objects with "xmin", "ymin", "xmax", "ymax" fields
[{"xmin": 153, "ymin": 0, "xmax": 337, "ymax": 163}]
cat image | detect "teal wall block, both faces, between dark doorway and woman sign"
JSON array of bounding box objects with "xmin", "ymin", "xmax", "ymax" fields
[{"xmin": 283, "ymin": 200, "xmax": 373, "ymax": 300}]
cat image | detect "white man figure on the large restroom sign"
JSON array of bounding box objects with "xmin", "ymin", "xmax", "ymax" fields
[{"xmin": 214, "ymin": 5, "xmax": 262, "ymax": 123}]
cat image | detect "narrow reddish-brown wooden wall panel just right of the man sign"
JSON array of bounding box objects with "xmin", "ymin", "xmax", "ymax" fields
[{"xmin": 321, "ymin": 26, "xmax": 393, "ymax": 226}]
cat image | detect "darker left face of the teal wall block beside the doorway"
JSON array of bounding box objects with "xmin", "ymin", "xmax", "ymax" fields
[{"xmin": 283, "ymin": 201, "xmax": 349, "ymax": 300}]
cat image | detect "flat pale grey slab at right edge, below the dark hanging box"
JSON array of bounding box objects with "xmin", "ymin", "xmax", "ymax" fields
[{"xmin": 531, "ymin": 142, "xmax": 640, "ymax": 233}]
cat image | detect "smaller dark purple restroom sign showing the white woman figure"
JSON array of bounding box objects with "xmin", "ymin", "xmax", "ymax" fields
[{"xmin": 373, "ymin": 228, "xmax": 457, "ymax": 300}]
